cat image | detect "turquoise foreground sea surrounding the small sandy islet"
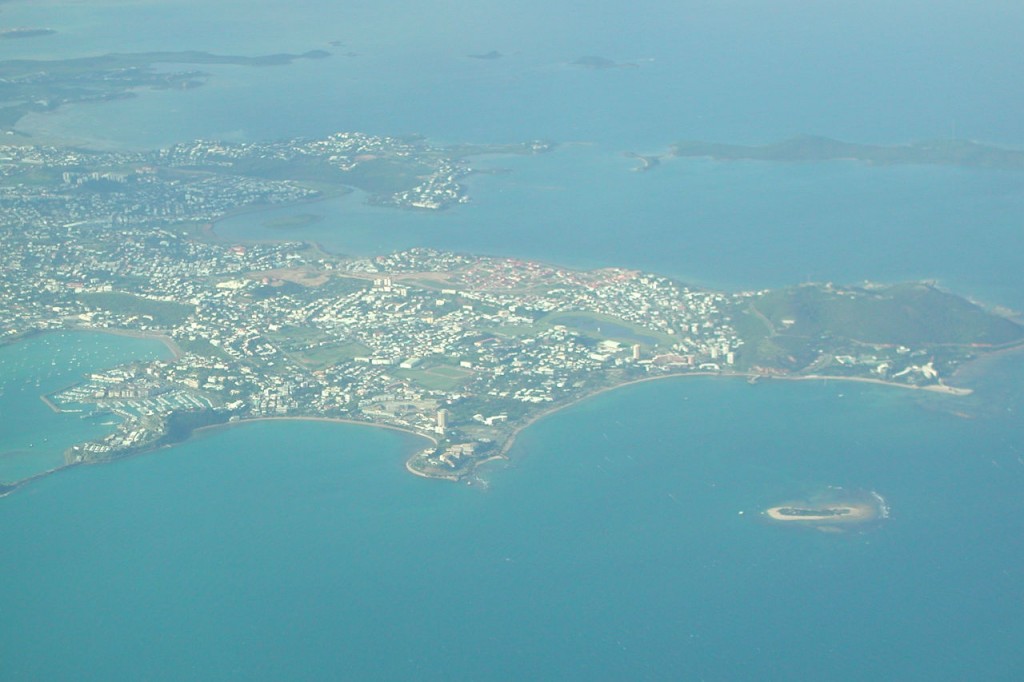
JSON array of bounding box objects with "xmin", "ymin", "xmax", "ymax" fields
[{"xmin": 0, "ymin": 374, "xmax": 1024, "ymax": 680}]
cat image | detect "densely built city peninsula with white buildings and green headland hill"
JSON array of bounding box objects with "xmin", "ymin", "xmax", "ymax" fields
[{"xmin": 0, "ymin": 133, "xmax": 1022, "ymax": 479}]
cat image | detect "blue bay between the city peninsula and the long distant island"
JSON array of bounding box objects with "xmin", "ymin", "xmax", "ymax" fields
[{"xmin": 216, "ymin": 144, "xmax": 1024, "ymax": 308}]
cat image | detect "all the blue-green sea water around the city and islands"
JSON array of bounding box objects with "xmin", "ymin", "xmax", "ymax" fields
[{"xmin": 0, "ymin": 0, "xmax": 1024, "ymax": 680}]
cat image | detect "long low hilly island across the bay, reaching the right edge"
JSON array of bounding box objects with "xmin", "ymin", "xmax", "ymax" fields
[{"xmin": 668, "ymin": 135, "xmax": 1024, "ymax": 169}]
